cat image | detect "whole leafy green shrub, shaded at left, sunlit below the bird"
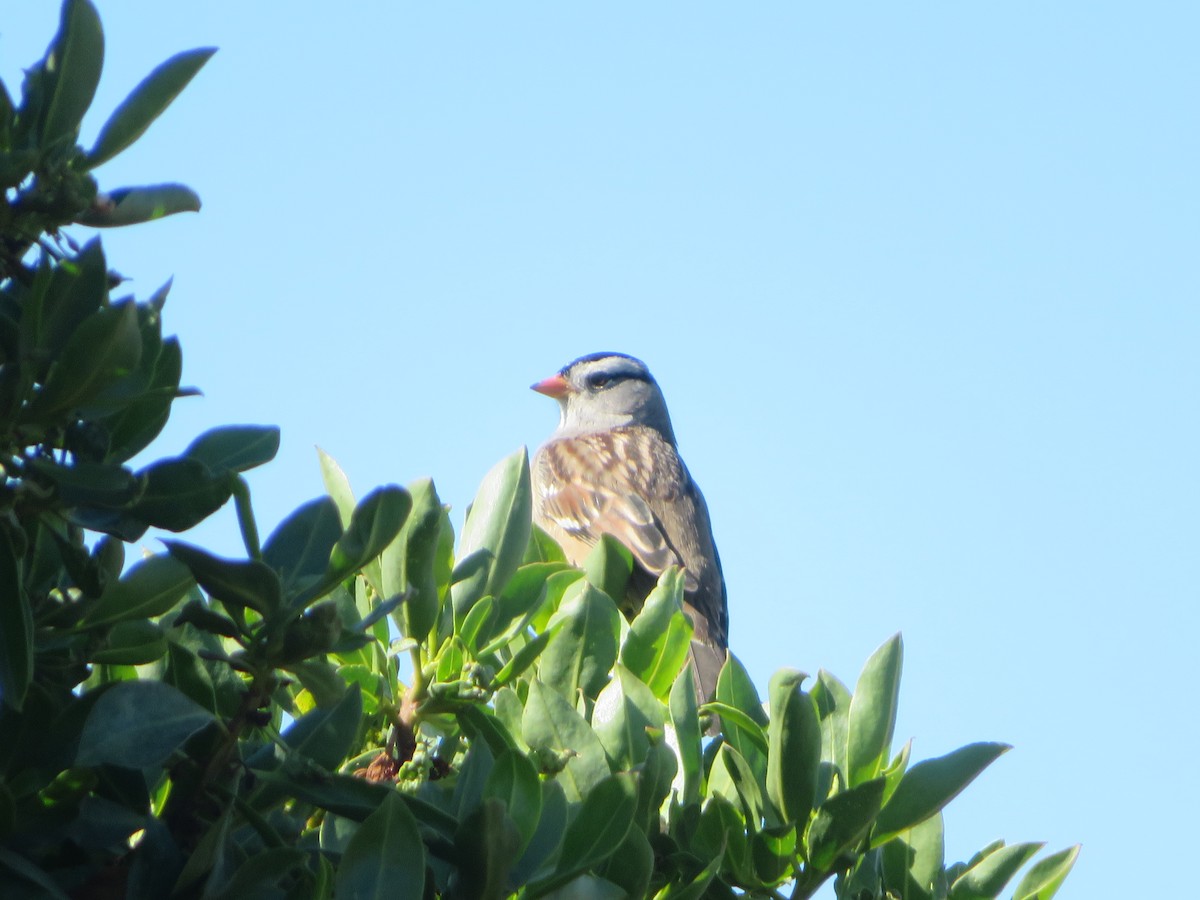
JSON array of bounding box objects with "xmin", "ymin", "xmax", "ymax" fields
[{"xmin": 0, "ymin": 0, "xmax": 1078, "ymax": 900}]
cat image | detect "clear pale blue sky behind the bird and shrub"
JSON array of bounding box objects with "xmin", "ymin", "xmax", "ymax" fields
[{"xmin": 0, "ymin": 0, "xmax": 1200, "ymax": 898}]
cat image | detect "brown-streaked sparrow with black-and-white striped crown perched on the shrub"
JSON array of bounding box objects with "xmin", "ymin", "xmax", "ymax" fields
[{"xmin": 533, "ymin": 353, "xmax": 728, "ymax": 701}]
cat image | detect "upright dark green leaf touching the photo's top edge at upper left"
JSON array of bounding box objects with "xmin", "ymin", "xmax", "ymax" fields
[{"xmin": 41, "ymin": 0, "xmax": 104, "ymax": 146}]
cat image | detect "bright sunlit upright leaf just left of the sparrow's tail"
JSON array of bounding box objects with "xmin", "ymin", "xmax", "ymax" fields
[{"xmin": 624, "ymin": 566, "xmax": 692, "ymax": 700}]
